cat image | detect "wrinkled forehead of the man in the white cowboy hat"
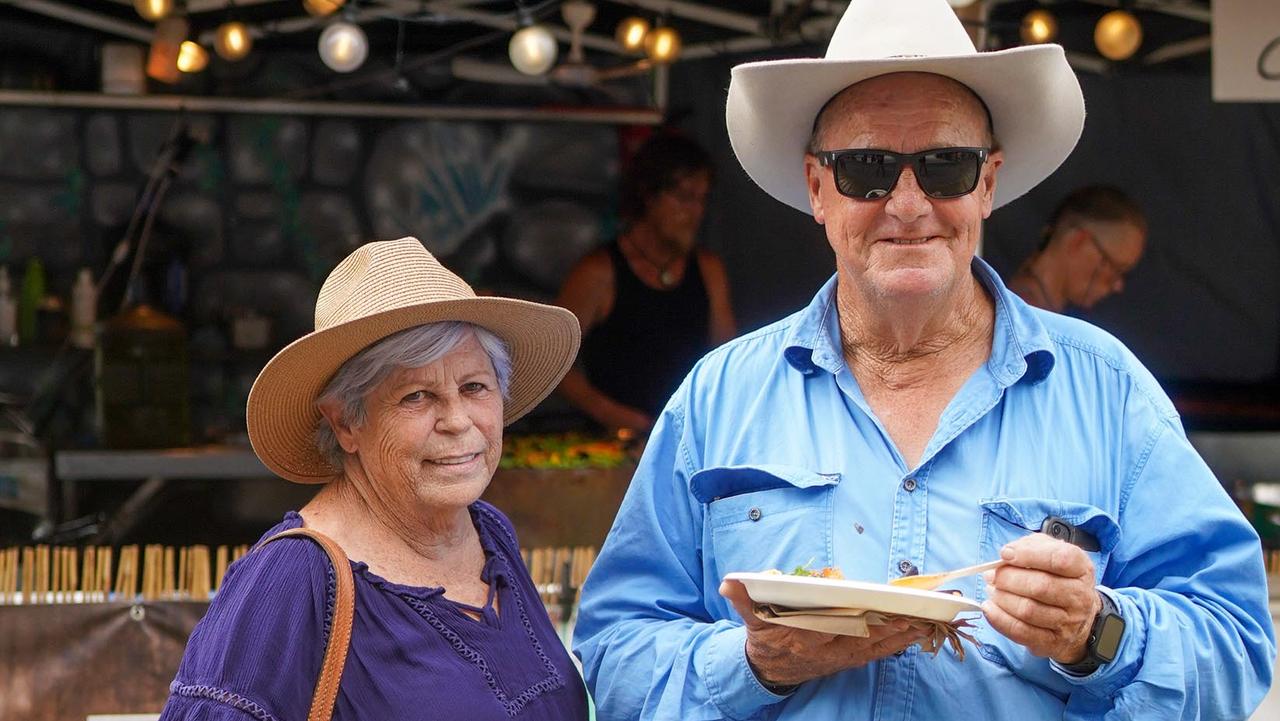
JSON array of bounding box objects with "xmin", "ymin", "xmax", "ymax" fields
[{"xmin": 814, "ymin": 73, "xmax": 995, "ymax": 146}]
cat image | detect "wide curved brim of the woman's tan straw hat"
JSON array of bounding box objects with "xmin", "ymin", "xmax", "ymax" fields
[{"xmin": 246, "ymin": 296, "xmax": 581, "ymax": 483}]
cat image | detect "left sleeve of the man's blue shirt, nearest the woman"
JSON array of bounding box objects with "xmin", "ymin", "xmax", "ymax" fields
[{"xmin": 573, "ymin": 394, "xmax": 785, "ymax": 720}]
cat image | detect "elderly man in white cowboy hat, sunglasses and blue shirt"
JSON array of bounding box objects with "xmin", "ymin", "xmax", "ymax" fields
[{"xmin": 575, "ymin": 0, "xmax": 1275, "ymax": 720}]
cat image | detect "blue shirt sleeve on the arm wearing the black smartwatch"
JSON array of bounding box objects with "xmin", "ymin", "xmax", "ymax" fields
[{"xmin": 1053, "ymin": 421, "xmax": 1276, "ymax": 720}]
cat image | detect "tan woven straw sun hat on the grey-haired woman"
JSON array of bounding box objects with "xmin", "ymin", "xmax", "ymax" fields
[{"xmin": 247, "ymin": 238, "xmax": 581, "ymax": 483}]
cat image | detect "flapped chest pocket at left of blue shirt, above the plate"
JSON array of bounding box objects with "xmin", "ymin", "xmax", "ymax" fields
[{"xmin": 690, "ymin": 465, "xmax": 840, "ymax": 579}]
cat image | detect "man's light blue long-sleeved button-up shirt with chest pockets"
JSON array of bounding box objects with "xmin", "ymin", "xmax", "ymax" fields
[{"xmin": 575, "ymin": 260, "xmax": 1275, "ymax": 721}]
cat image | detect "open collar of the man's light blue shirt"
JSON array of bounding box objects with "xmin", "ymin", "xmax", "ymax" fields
[{"xmin": 782, "ymin": 257, "xmax": 1053, "ymax": 387}]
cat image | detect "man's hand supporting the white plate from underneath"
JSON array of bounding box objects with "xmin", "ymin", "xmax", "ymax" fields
[{"xmin": 719, "ymin": 581, "xmax": 925, "ymax": 686}]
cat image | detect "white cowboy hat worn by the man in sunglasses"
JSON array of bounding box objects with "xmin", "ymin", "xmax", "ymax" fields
[{"xmin": 724, "ymin": 0, "xmax": 1084, "ymax": 213}]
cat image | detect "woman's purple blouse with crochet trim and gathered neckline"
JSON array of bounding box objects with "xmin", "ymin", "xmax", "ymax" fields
[{"xmin": 160, "ymin": 501, "xmax": 588, "ymax": 721}]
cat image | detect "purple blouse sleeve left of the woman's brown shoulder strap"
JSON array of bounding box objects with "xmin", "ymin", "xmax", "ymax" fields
[{"xmin": 160, "ymin": 538, "xmax": 334, "ymax": 721}]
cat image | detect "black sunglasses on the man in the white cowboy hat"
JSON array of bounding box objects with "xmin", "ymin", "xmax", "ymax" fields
[{"xmin": 814, "ymin": 147, "xmax": 991, "ymax": 200}]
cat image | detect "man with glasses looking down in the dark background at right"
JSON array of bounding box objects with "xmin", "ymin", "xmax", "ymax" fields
[{"xmin": 1009, "ymin": 186, "xmax": 1147, "ymax": 312}]
